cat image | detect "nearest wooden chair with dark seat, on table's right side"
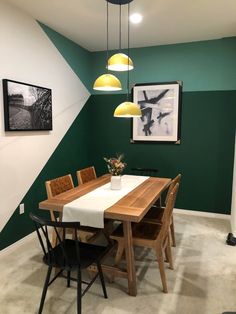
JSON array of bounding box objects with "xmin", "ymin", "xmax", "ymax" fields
[{"xmin": 111, "ymin": 183, "xmax": 179, "ymax": 293}]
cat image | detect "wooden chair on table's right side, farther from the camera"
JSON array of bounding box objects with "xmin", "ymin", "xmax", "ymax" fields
[{"xmin": 143, "ymin": 174, "xmax": 181, "ymax": 246}]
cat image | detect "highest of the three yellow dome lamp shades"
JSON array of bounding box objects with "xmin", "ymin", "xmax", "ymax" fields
[{"xmin": 107, "ymin": 53, "xmax": 134, "ymax": 71}]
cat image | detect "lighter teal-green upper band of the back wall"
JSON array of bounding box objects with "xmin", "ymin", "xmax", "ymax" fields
[{"xmin": 92, "ymin": 37, "xmax": 236, "ymax": 94}]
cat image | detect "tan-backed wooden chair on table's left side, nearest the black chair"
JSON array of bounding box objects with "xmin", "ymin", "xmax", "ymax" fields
[{"xmin": 45, "ymin": 174, "xmax": 97, "ymax": 245}]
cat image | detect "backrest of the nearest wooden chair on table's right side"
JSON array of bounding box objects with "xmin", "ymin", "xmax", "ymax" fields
[{"xmin": 160, "ymin": 183, "xmax": 179, "ymax": 240}]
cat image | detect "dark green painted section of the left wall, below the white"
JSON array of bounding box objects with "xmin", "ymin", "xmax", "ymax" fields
[{"xmin": 0, "ymin": 96, "xmax": 90, "ymax": 250}]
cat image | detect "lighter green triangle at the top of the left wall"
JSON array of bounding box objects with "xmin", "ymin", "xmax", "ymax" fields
[{"xmin": 38, "ymin": 22, "xmax": 92, "ymax": 92}]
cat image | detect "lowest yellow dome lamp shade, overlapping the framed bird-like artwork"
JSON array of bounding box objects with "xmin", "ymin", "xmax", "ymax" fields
[{"xmin": 114, "ymin": 101, "xmax": 142, "ymax": 118}]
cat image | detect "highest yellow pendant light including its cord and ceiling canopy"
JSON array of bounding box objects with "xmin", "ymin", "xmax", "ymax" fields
[{"xmin": 107, "ymin": 0, "xmax": 134, "ymax": 72}]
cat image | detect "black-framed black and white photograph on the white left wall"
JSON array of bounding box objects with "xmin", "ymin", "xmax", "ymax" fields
[{"xmin": 3, "ymin": 79, "xmax": 52, "ymax": 131}]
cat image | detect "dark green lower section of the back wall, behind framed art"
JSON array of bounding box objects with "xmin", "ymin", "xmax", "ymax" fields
[{"xmin": 87, "ymin": 91, "xmax": 236, "ymax": 214}]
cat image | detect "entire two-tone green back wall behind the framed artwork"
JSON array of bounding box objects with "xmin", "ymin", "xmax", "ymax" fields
[{"xmin": 90, "ymin": 37, "xmax": 236, "ymax": 214}]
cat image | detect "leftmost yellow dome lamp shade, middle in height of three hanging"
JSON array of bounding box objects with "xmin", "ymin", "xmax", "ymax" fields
[{"xmin": 93, "ymin": 74, "xmax": 122, "ymax": 91}]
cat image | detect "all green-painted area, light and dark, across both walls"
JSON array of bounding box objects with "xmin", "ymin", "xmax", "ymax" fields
[{"xmin": 0, "ymin": 28, "xmax": 236, "ymax": 249}]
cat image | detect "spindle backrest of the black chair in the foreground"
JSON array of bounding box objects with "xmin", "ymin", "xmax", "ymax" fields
[{"xmin": 30, "ymin": 213, "xmax": 80, "ymax": 269}]
